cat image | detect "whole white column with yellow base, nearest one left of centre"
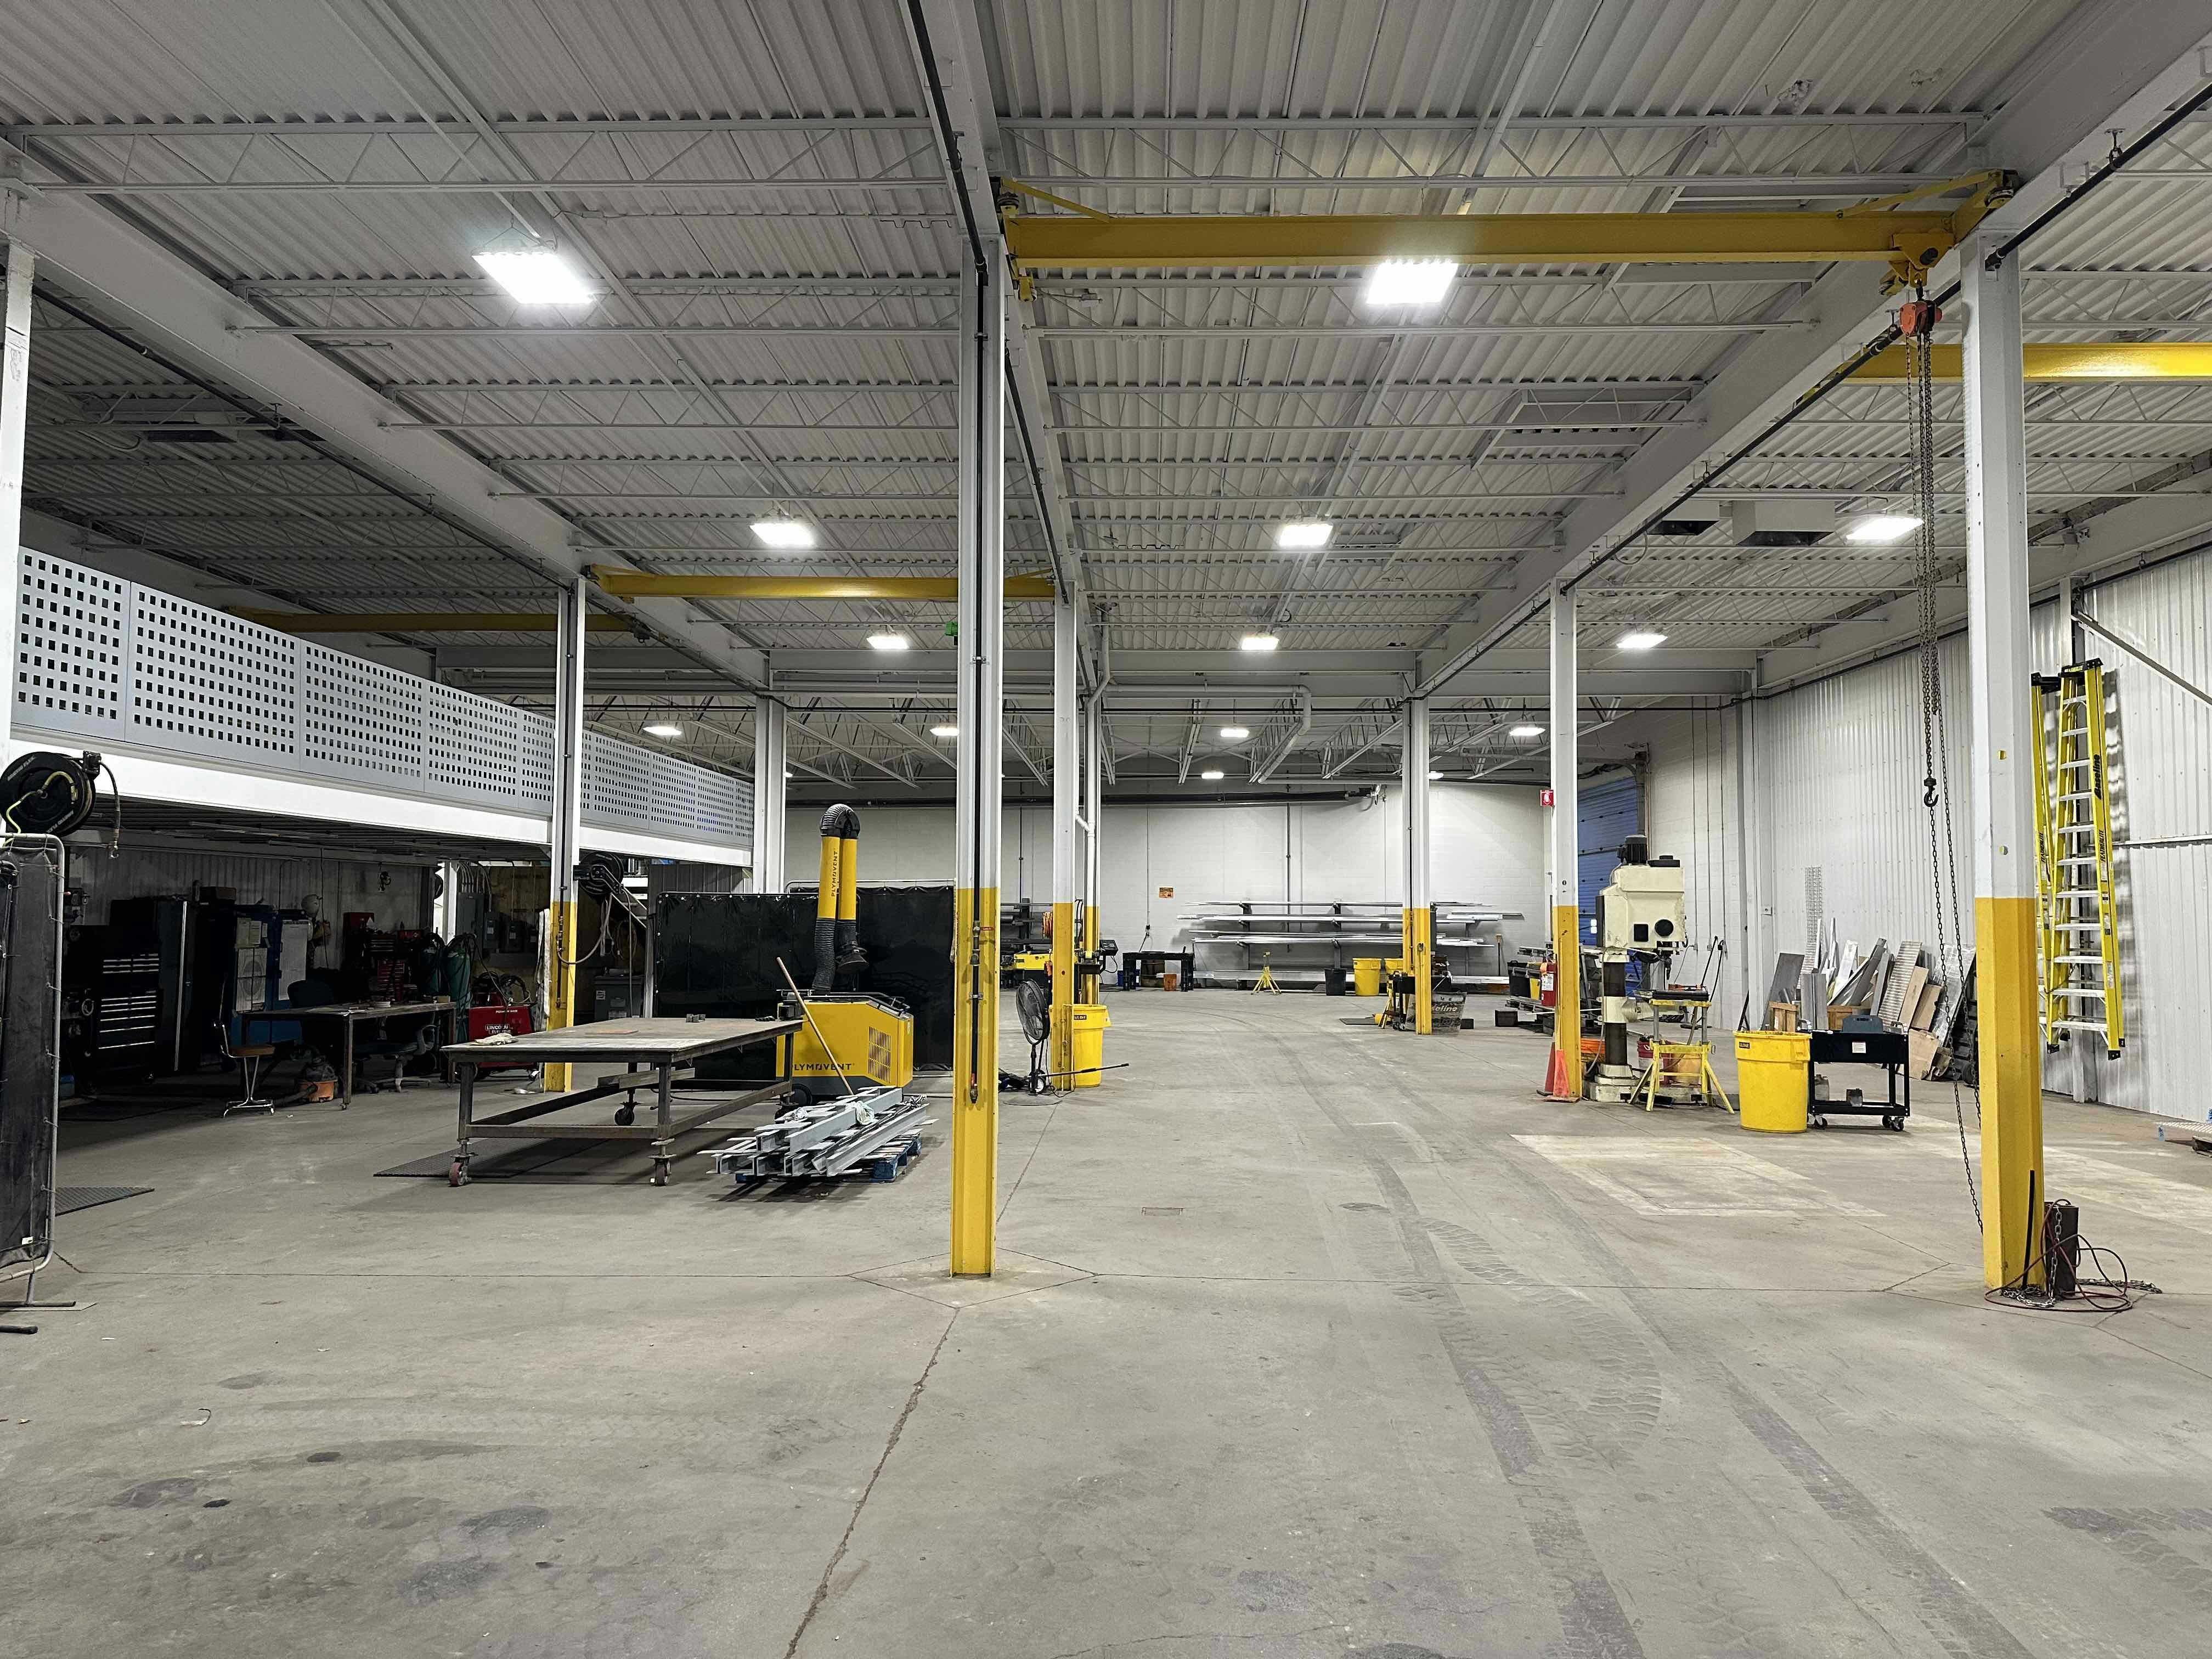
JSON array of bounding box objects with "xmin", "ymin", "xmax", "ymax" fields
[{"xmin": 951, "ymin": 244, "xmax": 1007, "ymax": 1274}]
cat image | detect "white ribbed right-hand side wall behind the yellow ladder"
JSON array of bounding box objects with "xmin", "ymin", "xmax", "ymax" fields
[{"xmin": 1630, "ymin": 541, "xmax": 2212, "ymax": 1119}]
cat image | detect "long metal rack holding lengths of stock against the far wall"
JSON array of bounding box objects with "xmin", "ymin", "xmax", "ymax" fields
[{"xmin": 1177, "ymin": 898, "xmax": 1522, "ymax": 991}]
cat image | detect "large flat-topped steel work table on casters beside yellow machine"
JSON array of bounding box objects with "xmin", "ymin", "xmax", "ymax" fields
[{"xmin": 447, "ymin": 1020, "xmax": 801, "ymax": 1186}]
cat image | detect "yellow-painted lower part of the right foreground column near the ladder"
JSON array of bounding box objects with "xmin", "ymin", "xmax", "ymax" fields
[{"xmin": 1973, "ymin": 898, "xmax": 2051, "ymax": 1290}]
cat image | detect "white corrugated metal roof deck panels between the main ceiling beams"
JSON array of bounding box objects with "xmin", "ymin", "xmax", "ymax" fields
[{"xmin": 0, "ymin": 0, "xmax": 2212, "ymax": 787}]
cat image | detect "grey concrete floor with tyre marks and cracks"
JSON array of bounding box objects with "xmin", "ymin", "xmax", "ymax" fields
[{"xmin": 0, "ymin": 993, "xmax": 2212, "ymax": 1659}]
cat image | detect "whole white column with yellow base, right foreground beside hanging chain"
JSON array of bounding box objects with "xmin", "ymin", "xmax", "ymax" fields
[{"xmin": 1960, "ymin": 236, "xmax": 2046, "ymax": 1288}]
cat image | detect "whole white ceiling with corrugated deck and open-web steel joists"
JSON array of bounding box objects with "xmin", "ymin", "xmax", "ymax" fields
[{"xmin": 0, "ymin": 0, "xmax": 2212, "ymax": 799}]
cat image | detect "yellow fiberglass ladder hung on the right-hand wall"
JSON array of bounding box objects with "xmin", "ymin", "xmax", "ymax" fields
[{"xmin": 2035, "ymin": 662, "xmax": 2126, "ymax": 1059}]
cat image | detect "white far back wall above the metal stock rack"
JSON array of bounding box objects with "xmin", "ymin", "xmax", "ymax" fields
[{"xmin": 785, "ymin": 783, "xmax": 1544, "ymax": 947}]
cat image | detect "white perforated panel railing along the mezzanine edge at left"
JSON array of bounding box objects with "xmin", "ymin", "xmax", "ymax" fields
[{"xmin": 15, "ymin": 551, "xmax": 752, "ymax": 845}]
